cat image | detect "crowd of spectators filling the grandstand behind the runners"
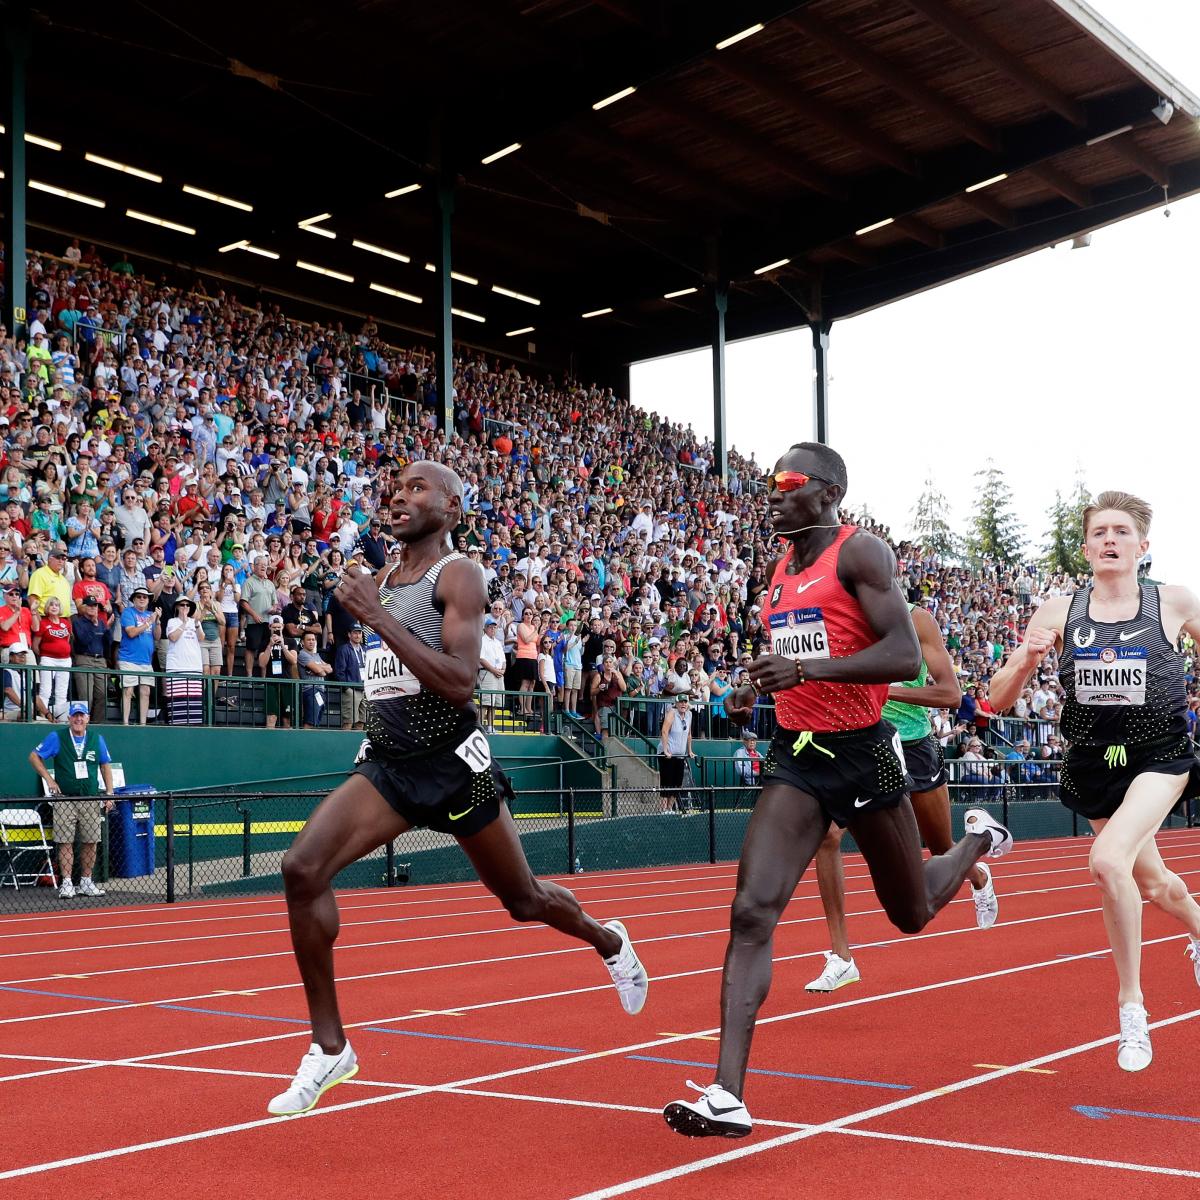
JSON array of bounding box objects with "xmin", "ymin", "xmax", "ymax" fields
[{"xmin": 0, "ymin": 244, "xmax": 1113, "ymax": 780}]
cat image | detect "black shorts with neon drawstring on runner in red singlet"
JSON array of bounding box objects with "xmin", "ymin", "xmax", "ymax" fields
[{"xmin": 762, "ymin": 721, "xmax": 912, "ymax": 827}]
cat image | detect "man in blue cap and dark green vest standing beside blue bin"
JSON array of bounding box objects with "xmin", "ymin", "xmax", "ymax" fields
[{"xmin": 29, "ymin": 700, "xmax": 113, "ymax": 900}]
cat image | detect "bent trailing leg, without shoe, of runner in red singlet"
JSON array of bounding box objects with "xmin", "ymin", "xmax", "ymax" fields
[{"xmin": 850, "ymin": 797, "xmax": 991, "ymax": 934}]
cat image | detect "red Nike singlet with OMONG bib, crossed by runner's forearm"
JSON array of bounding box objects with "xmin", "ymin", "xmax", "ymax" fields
[{"xmin": 762, "ymin": 526, "xmax": 888, "ymax": 733}]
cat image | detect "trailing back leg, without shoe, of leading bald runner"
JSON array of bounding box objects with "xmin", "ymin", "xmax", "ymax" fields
[{"xmin": 458, "ymin": 804, "xmax": 622, "ymax": 959}]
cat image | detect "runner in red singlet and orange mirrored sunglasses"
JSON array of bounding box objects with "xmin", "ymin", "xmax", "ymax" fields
[{"xmin": 664, "ymin": 442, "xmax": 1013, "ymax": 1138}]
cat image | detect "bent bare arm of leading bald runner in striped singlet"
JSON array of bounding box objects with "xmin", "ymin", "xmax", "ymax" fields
[{"xmin": 337, "ymin": 559, "xmax": 487, "ymax": 706}]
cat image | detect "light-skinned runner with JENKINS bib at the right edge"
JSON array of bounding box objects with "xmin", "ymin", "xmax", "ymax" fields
[{"xmin": 989, "ymin": 492, "xmax": 1200, "ymax": 1070}]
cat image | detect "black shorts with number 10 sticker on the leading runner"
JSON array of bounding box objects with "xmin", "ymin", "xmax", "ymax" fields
[{"xmin": 353, "ymin": 730, "xmax": 512, "ymax": 838}]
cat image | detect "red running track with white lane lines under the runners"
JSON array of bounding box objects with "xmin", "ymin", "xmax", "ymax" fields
[{"xmin": 0, "ymin": 829, "xmax": 1200, "ymax": 1200}]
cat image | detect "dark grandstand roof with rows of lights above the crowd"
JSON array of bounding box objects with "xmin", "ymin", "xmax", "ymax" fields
[{"xmin": 11, "ymin": 0, "xmax": 1200, "ymax": 374}]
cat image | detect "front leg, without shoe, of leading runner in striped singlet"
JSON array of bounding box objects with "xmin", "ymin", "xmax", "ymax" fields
[{"xmin": 283, "ymin": 775, "xmax": 410, "ymax": 1054}]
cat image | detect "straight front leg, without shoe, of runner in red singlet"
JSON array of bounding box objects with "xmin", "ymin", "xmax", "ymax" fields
[{"xmin": 716, "ymin": 784, "xmax": 829, "ymax": 1097}]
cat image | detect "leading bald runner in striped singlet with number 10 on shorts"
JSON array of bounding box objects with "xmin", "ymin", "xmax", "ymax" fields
[{"xmin": 268, "ymin": 462, "xmax": 649, "ymax": 1116}]
